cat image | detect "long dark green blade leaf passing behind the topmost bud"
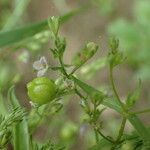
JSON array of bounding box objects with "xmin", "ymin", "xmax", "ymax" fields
[{"xmin": 0, "ymin": 9, "xmax": 81, "ymax": 47}]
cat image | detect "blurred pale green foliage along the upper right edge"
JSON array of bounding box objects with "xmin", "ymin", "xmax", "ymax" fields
[{"xmin": 108, "ymin": 0, "xmax": 150, "ymax": 80}]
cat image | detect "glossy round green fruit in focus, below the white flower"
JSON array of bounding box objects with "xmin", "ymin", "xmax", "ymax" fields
[{"xmin": 27, "ymin": 77, "xmax": 56, "ymax": 105}]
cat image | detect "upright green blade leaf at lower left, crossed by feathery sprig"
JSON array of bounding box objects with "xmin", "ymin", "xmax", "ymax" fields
[{"xmin": 8, "ymin": 87, "xmax": 29, "ymax": 150}]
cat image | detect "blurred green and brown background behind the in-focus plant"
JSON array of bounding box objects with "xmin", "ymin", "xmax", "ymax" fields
[{"xmin": 0, "ymin": 0, "xmax": 150, "ymax": 150}]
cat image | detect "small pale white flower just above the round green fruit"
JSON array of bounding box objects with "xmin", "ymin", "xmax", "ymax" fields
[{"xmin": 33, "ymin": 56, "xmax": 48, "ymax": 77}]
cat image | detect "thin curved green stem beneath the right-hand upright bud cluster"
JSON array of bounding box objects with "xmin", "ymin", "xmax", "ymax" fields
[{"xmin": 109, "ymin": 66, "xmax": 127, "ymax": 112}]
